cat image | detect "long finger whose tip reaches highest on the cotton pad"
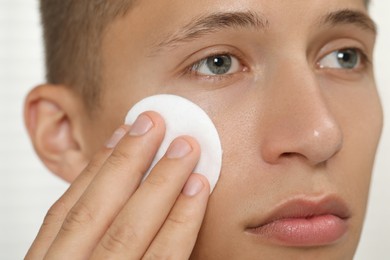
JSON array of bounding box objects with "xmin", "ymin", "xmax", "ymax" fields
[{"xmin": 47, "ymin": 112, "xmax": 165, "ymax": 259}]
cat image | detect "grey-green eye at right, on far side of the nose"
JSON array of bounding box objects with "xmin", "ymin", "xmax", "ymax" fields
[{"xmin": 318, "ymin": 48, "xmax": 362, "ymax": 70}]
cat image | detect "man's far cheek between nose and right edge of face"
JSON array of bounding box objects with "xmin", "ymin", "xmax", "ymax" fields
[{"xmin": 328, "ymin": 83, "xmax": 383, "ymax": 238}]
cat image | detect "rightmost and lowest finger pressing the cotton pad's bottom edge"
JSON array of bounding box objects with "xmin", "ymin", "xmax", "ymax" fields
[{"xmin": 143, "ymin": 174, "xmax": 210, "ymax": 259}]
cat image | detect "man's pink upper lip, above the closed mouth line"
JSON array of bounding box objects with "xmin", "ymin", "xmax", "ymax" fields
[{"xmin": 248, "ymin": 196, "xmax": 350, "ymax": 229}]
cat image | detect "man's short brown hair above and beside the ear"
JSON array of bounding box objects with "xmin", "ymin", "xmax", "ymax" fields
[{"xmin": 40, "ymin": 0, "xmax": 135, "ymax": 108}]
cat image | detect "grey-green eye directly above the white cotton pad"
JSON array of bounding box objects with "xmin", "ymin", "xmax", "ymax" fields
[{"xmin": 191, "ymin": 54, "xmax": 241, "ymax": 76}]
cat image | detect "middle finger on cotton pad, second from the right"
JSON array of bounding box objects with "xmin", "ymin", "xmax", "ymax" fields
[{"xmin": 92, "ymin": 137, "xmax": 200, "ymax": 259}]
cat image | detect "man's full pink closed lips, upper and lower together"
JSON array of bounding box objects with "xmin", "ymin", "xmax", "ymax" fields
[{"xmin": 246, "ymin": 196, "xmax": 350, "ymax": 247}]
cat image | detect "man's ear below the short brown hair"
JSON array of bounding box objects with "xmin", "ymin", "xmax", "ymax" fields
[{"xmin": 24, "ymin": 85, "xmax": 88, "ymax": 182}]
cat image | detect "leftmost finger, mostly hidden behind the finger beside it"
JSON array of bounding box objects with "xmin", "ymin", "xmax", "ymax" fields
[{"xmin": 26, "ymin": 125, "xmax": 129, "ymax": 259}]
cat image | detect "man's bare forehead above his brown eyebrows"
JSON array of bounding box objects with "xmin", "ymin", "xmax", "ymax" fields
[{"xmin": 123, "ymin": 0, "xmax": 367, "ymax": 34}]
